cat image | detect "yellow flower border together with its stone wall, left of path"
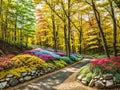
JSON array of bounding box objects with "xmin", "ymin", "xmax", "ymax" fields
[{"xmin": 0, "ymin": 54, "xmax": 82, "ymax": 88}]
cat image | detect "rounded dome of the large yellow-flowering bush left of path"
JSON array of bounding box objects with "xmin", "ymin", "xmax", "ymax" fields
[{"xmin": 12, "ymin": 54, "xmax": 45, "ymax": 69}]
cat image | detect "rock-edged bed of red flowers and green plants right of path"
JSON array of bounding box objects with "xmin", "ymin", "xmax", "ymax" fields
[{"xmin": 78, "ymin": 56, "xmax": 120, "ymax": 88}]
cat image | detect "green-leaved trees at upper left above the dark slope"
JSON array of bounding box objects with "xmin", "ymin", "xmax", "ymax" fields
[{"xmin": 0, "ymin": 0, "xmax": 35, "ymax": 49}]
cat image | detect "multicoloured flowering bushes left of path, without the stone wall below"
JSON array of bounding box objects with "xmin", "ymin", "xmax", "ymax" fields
[{"xmin": 0, "ymin": 48, "xmax": 83, "ymax": 79}]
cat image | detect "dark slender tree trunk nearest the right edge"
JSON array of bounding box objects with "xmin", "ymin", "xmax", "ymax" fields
[{"xmin": 109, "ymin": 0, "xmax": 117, "ymax": 56}]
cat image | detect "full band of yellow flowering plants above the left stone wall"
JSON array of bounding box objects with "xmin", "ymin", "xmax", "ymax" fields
[{"xmin": 0, "ymin": 54, "xmax": 67, "ymax": 79}]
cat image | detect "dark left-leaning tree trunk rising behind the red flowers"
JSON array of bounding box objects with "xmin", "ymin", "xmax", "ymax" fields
[{"xmin": 92, "ymin": 0, "xmax": 110, "ymax": 58}]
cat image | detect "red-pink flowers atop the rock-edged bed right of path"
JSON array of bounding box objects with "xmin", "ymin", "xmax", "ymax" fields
[{"xmin": 91, "ymin": 56, "xmax": 120, "ymax": 72}]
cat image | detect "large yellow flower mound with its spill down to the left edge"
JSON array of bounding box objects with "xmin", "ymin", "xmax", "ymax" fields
[{"xmin": 0, "ymin": 54, "xmax": 48, "ymax": 79}]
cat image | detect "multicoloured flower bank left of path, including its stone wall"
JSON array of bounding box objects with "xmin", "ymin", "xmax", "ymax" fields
[{"xmin": 0, "ymin": 48, "xmax": 83, "ymax": 88}]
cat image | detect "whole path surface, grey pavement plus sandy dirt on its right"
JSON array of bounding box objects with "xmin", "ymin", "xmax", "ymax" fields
[{"xmin": 7, "ymin": 58, "xmax": 91, "ymax": 90}]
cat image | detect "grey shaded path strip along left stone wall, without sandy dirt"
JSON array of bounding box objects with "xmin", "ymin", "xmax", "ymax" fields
[{"xmin": 9, "ymin": 58, "xmax": 91, "ymax": 90}]
